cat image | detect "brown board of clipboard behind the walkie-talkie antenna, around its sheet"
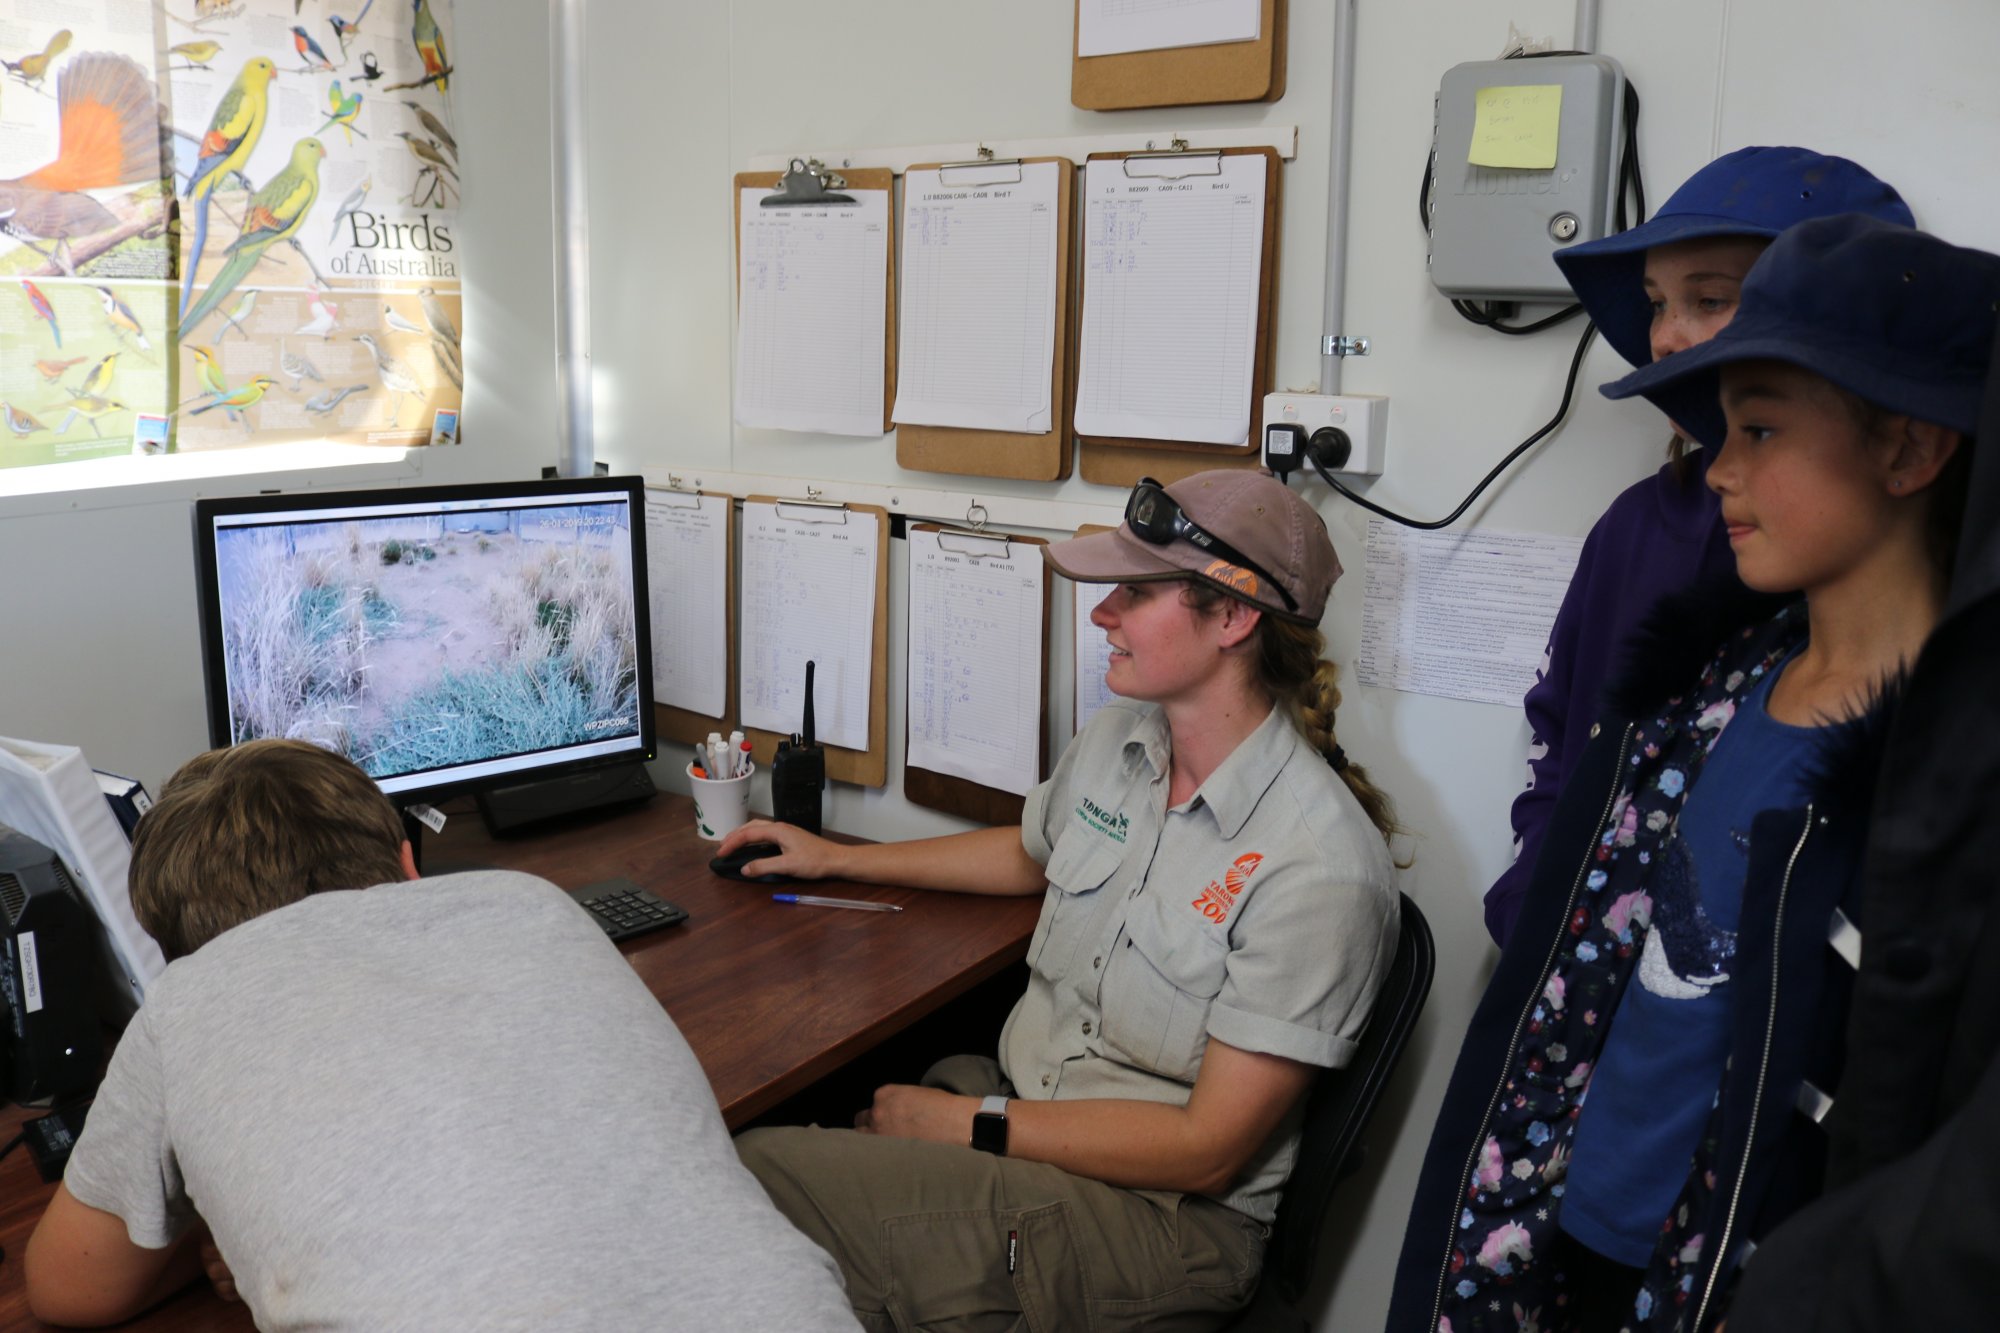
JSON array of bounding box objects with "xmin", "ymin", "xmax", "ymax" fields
[{"xmin": 738, "ymin": 494, "xmax": 888, "ymax": 787}]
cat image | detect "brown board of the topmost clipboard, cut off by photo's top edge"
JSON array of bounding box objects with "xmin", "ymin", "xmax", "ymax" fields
[{"xmin": 1070, "ymin": 0, "xmax": 1288, "ymax": 110}]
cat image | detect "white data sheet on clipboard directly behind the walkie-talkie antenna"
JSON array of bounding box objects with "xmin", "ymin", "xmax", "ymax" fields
[{"xmin": 738, "ymin": 500, "xmax": 882, "ymax": 751}]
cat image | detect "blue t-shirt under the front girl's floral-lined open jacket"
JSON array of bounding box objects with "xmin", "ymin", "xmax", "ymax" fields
[{"xmin": 1560, "ymin": 667, "xmax": 1818, "ymax": 1267}]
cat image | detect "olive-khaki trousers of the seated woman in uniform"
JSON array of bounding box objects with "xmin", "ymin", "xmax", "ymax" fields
[{"xmin": 736, "ymin": 1055, "xmax": 1266, "ymax": 1333}]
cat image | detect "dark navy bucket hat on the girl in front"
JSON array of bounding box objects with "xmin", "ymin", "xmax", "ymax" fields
[{"xmin": 1602, "ymin": 214, "xmax": 2000, "ymax": 446}]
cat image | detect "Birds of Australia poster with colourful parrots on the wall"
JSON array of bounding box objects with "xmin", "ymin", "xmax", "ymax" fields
[{"xmin": 0, "ymin": 0, "xmax": 464, "ymax": 466}]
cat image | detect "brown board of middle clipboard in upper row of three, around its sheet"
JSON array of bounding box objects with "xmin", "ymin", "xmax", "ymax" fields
[{"xmin": 890, "ymin": 158, "xmax": 1076, "ymax": 480}]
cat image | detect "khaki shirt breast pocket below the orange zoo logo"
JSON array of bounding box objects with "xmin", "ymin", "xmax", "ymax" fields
[{"xmin": 1098, "ymin": 880, "xmax": 1230, "ymax": 1083}]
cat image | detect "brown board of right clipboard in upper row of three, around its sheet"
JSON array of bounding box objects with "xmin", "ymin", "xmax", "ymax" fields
[{"xmin": 1070, "ymin": 148, "xmax": 1282, "ymax": 486}]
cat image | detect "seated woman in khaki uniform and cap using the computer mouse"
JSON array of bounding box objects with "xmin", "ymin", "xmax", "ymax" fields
[{"xmin": 722, "ymin": 472, "xmax": 1396, "ymax": 1331}]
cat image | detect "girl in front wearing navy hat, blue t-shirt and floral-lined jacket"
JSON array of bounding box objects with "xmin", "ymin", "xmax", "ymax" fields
[{"xmin": 1390, "ymin": 214, "xmax": 2000, "ymax": 1333}]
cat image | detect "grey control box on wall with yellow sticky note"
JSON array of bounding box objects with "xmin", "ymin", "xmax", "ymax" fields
[{"xmin": 1430, "ymin": 56, "xmax": 1626, "ymax": 304}]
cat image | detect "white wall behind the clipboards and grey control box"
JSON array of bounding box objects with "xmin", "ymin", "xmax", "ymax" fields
[{"xmin": 0, "ymin": 0, "xmax": 2000, "ymax": 1329}]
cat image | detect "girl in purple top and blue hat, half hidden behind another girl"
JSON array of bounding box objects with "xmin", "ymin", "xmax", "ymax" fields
[{"xmin": 1486, "ymin": 148, "xmax": 1912, "ymax": 945}]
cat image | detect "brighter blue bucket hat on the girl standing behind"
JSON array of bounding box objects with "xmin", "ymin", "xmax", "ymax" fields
[{"xmin": 1556, "ymin": 148, "xmax": 1916, "ymax": 366}]
